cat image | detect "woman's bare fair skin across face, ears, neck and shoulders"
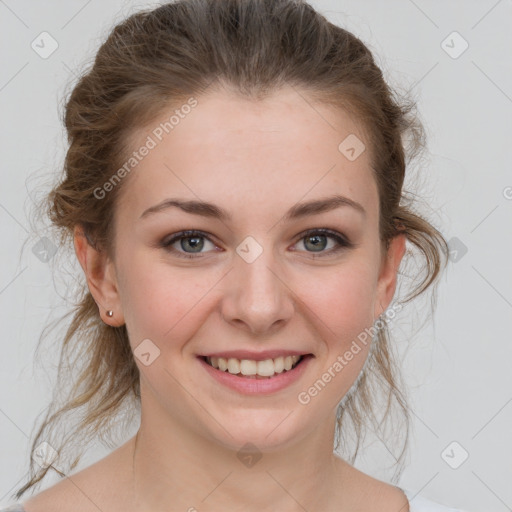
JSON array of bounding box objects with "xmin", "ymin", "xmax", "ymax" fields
[{"xmin": 26, "ymin": 88, "xmax": 409, "ymax": 512}]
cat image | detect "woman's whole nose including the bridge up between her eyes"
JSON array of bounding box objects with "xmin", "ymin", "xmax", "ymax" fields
[{"xmin": 223, "ymin": 237, "xmax": 293, "ymax": 332}]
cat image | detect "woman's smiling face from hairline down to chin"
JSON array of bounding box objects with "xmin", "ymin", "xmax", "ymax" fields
[{"xmin": 92, "ymin": 88, "xmax": 404, "ymax": 451}]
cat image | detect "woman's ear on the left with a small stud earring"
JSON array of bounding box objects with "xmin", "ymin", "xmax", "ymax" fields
[{"xmin": 74, "ymin": 225, "xmax": 124, "ymax": 327}]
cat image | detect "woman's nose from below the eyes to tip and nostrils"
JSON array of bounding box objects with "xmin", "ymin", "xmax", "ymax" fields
[{"xmin": 221, "ymin": 244, "xmax": 295, "ymax": 335}]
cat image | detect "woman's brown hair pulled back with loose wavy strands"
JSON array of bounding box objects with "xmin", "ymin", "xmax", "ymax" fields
[{"xmin": 16, "ymin": 0, "xmax": 447, "ymax": 498}]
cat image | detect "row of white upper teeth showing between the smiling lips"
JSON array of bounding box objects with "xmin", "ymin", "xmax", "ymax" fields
[{"xmin": 199, "ymin": 354, "xmax": 314, "ymax": 380}]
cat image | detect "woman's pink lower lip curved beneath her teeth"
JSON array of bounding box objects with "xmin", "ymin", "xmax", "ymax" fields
[{"xmin": 198, "ymin": 354, "xmax": 314, "ymax": 395}]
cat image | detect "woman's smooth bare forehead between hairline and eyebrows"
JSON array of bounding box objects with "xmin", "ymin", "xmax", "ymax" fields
[{"xmin": 114, "ymin": 87, "xmax": 376, "ymax": 224}]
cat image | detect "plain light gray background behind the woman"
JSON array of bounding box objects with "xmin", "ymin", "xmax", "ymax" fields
[{"xmin": 0, "ymin": 0, "xmax": 512, "ymax": 512}]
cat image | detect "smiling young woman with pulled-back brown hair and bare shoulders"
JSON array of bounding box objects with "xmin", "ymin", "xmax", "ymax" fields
[{"xmin": 1, "ymin": 0, "xmax": 468, "ymax": 512}]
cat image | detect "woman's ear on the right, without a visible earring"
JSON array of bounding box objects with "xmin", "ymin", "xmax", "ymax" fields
[{"xmin": 374, "ymin": 234, "xmax": 406, "ymax": 318}]
